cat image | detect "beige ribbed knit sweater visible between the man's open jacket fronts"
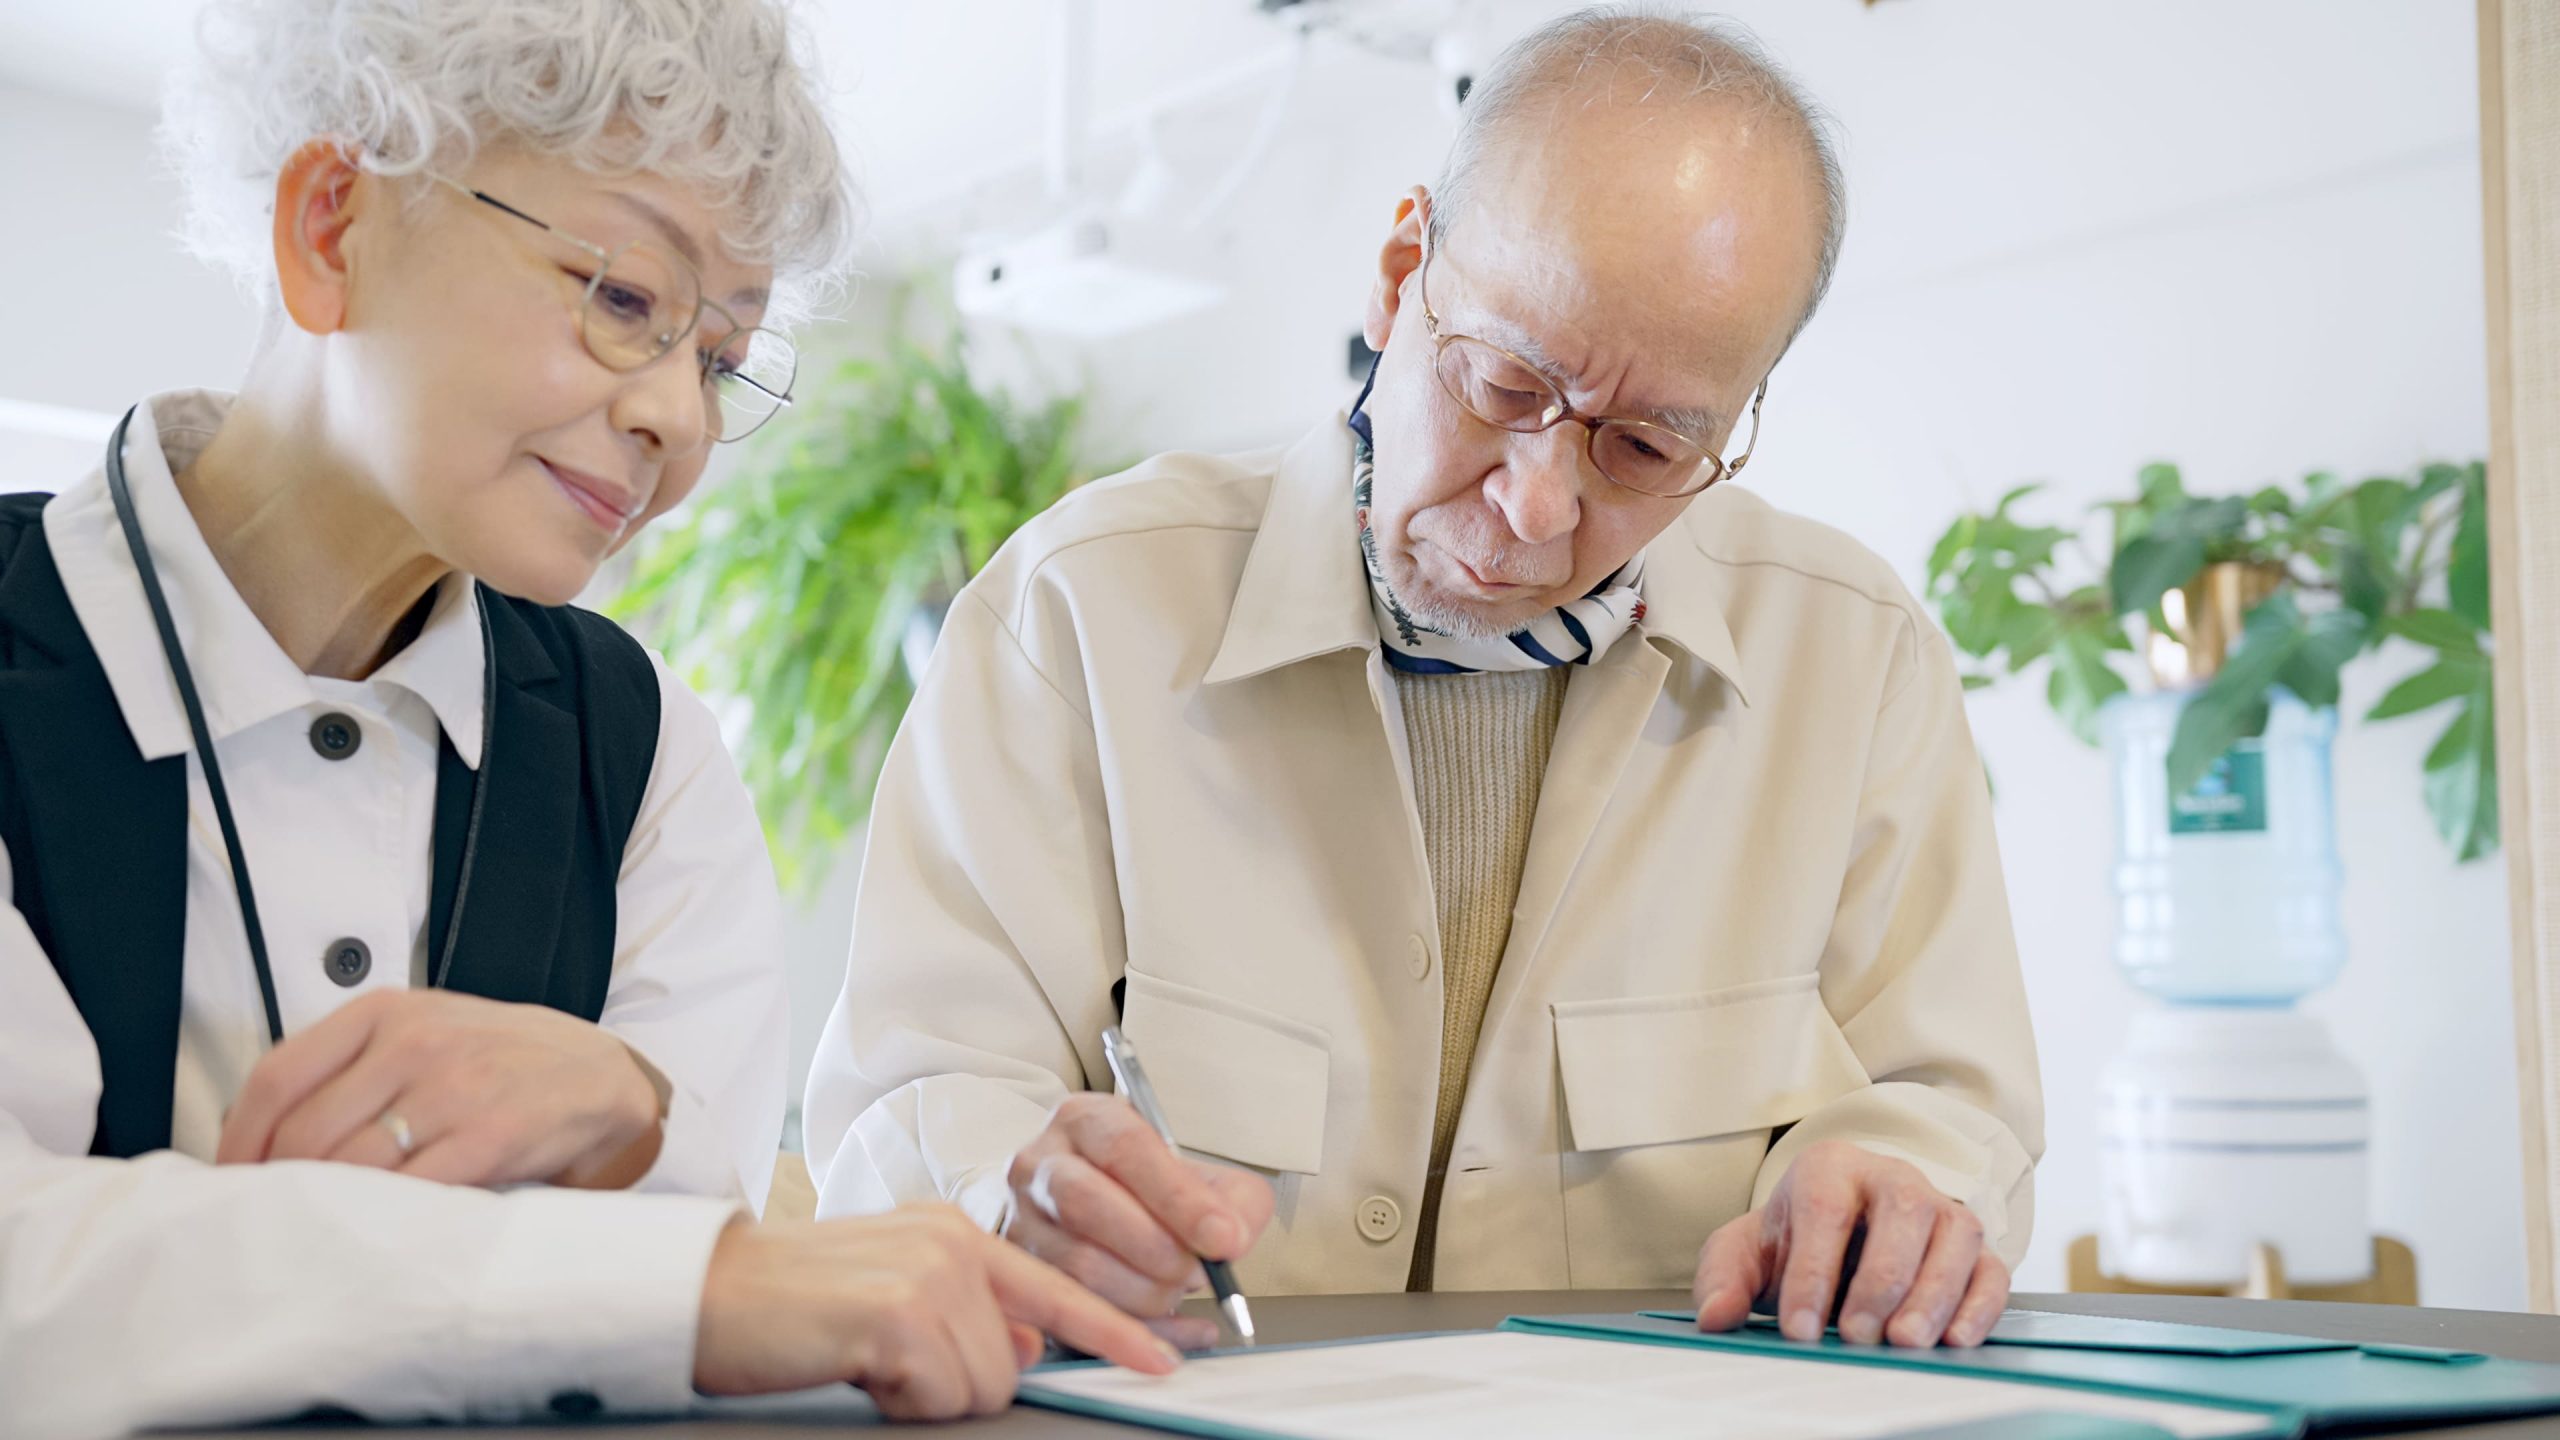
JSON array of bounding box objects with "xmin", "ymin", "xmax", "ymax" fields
[{"xmin": 1395, "ymin": 666, "xmax": 1572, "ymax": 1289}]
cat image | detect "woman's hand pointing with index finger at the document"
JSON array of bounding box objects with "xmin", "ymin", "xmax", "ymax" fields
[{"xmin": 694, "ymin": 1204, "xmax": 1180, "ymax": 1420}]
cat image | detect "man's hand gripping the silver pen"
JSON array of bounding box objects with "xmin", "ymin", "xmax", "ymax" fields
[{"xmin": 1006, "ymin": 1094, "xmax": 1272, "ymax": 1348}]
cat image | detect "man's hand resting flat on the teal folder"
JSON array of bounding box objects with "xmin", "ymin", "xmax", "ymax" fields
[{"xmin": 1690, "ymin": 1140, "xmax": 2010, "ymax": 1348}]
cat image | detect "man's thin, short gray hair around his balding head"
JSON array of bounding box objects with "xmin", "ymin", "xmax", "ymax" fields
[{"xmin": 1431, "ymin": 5, "xmax": 1848, "ymax": 343}]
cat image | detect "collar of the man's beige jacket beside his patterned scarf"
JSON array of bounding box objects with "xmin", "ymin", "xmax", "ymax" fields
[{"xmin": 1201, "ymin": 410, "xmax": 1748, "ymax": 705}]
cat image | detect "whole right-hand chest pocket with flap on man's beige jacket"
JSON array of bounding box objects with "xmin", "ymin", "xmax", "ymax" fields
[{"xmin": 1554, "ymin": 974, "xmax": 1866, "ymax": 1286}]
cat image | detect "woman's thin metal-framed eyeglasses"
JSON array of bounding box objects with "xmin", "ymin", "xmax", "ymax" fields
[{"xmin": 428, "ymin": 169, "xmax": 799, "ymax": 441}]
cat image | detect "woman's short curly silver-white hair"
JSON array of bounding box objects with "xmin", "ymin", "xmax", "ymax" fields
[{"xmin": 161, "ymin": 0, "xmax": 858, "ymax": 325}]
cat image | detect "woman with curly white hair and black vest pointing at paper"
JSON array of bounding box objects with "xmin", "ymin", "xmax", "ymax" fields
[{"xmin": 0, "ymin": 0, "xmax": 1170, "ymax": 1435}]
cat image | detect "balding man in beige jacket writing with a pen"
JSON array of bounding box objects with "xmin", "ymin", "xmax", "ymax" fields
[{"xmin": 806, "ymin": 10, "xmax": 2040, "ymax": 1345}]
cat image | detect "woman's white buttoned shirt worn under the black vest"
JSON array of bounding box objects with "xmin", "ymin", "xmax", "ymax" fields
[{"xmin": 0, "ymin": 392, "xmax": 786, "ymax": 1435}]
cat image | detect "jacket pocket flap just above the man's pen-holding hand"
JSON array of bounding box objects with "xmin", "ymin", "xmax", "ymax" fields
[{"xmin": 1121, "ymin": 971, "xmax": 1334, "ymax": 1176}]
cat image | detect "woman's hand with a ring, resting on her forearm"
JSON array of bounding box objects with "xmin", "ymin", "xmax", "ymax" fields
[{"xmin": 215, "ymin": 989, "xmax": 660, "ymax": 1189}]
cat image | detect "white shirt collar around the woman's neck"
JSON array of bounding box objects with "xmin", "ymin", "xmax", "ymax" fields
[{"xmin": 44, "ymin": 389, "xmax": 484, "ymax": 766}]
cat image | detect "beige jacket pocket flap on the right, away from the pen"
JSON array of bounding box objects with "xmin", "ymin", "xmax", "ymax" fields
[{"xmin": 1554, "ymin": 976, "xmax": 1866, "ymax": 1150}]
